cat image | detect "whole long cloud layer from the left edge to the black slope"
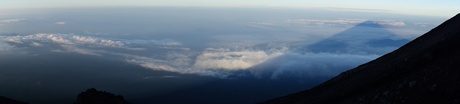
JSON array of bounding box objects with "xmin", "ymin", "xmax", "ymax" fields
[{"xmin": 1, "ymin": 34, "xmax": 384, "ymax": 79}]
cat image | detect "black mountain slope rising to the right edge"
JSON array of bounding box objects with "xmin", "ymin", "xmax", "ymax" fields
[{"xmin": 263, "ymin": 14, "xmax": 460, "ymax": 104}]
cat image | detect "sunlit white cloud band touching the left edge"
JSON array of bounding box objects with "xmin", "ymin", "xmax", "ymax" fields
[{"xmin": 0, "ymin": 33, "xmax": 131, "ymax": 56}]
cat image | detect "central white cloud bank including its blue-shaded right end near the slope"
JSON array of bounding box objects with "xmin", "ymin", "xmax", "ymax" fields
[{"xmin": 122, "ymin": 48, "xmax": 379, "ymax": 79}]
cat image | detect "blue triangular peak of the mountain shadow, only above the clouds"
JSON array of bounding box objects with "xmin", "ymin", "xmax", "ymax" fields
[{"xmin": 307, "ymin": 21, "xmax": 409, "ymax": 54}]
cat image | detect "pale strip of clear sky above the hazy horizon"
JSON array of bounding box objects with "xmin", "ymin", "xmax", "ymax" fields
[{"xmin": 0, "ymin": 0, "xmax": 460, "ymax": 17}]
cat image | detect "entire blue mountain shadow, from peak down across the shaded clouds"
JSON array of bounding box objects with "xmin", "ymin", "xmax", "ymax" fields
[{"xmin": 244, "ymin": 21, "xmax": 410, "ymax": 82}]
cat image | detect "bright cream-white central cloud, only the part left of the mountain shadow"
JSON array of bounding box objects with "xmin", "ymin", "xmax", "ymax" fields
[{"xmin": 111, "ymin": 48, "xmax": 286, "ymax": 78}]
